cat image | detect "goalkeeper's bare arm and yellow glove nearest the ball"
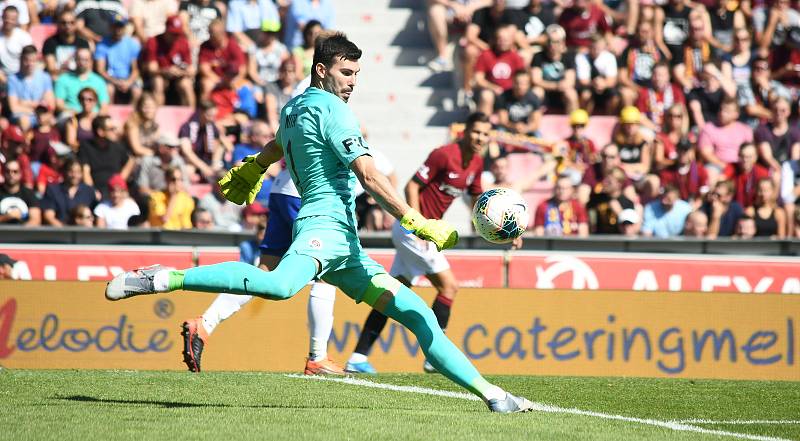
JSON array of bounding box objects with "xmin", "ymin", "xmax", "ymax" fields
[{"xmin": 350, "ymin": 155, "xmax": 458, "ymax": 251}]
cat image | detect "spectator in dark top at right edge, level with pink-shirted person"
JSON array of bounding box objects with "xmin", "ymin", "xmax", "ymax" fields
[{"xmin": 754, "ymin": 95, "xmax": 800, "ymax": 182}]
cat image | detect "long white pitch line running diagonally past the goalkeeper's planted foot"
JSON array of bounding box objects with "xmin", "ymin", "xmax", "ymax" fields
[{"xmin": 284, "ymin": 374, "xmax": 791, "ymax": 441}]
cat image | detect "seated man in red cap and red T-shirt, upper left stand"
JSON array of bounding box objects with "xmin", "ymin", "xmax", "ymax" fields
[{"xmin": 144, "ymin": 16, "xmax": 195, "ymax": 107}]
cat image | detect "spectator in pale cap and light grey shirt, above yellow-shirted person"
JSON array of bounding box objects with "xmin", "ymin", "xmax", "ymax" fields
[{"xmin": 136, "ymin": 133, "xmax": 190, "ymax": 195}]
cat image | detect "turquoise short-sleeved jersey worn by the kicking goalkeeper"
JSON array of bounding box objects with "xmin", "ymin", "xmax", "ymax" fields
[{"xmin": 276, "ymin": 87, "xmax": 369, "ymax": 231}]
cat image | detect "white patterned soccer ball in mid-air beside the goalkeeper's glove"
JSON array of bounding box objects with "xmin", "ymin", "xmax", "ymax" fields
[{"xmin": 472, "ymin": 188, "xmax": 529, "ymax": 243}]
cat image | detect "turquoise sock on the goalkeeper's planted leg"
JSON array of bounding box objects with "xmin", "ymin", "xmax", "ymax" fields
[{"xmin": 384, "ymin": 286, "xmax": 505, "ymax": 400}]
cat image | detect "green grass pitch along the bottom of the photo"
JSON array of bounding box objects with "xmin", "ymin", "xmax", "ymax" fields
[{"xmin": 0, "ymin": 369, "xmax": 800, "ymax": 441}]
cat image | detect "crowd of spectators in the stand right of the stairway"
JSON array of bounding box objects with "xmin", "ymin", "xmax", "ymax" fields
[{"xmin": 428, "ymin": 0, "xmax": 800, "ymax": 238}]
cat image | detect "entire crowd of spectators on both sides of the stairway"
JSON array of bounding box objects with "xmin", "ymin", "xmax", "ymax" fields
[{"xmin": 0, "ymin": 0, "xmax": 800, "ymax": 238}]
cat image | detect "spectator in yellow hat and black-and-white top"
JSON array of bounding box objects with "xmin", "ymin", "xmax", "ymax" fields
[{"xmin": 611, "ymin": 106, "xmax": 659, "ymax": 199}]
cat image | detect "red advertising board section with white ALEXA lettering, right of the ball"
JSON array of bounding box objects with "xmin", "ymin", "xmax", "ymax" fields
[{"xmin": 508, "ymin": 253, "xmax": 800, "ymax": 294}]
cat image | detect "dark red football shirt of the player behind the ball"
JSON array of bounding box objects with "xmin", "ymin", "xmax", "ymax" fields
[{"xmin": 414, "ymin": 143, "xmax": 483, "ymax": 219}]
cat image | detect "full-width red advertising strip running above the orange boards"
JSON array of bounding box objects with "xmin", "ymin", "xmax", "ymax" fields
[{"xmin": 0, "ymin": 245, "xmax": 800, "ymax": 294}]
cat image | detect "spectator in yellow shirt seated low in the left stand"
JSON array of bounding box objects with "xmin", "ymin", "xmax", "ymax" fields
[{"xmin": 148, "ymin": 167, "xmax": 194, "ymax": 230}]
